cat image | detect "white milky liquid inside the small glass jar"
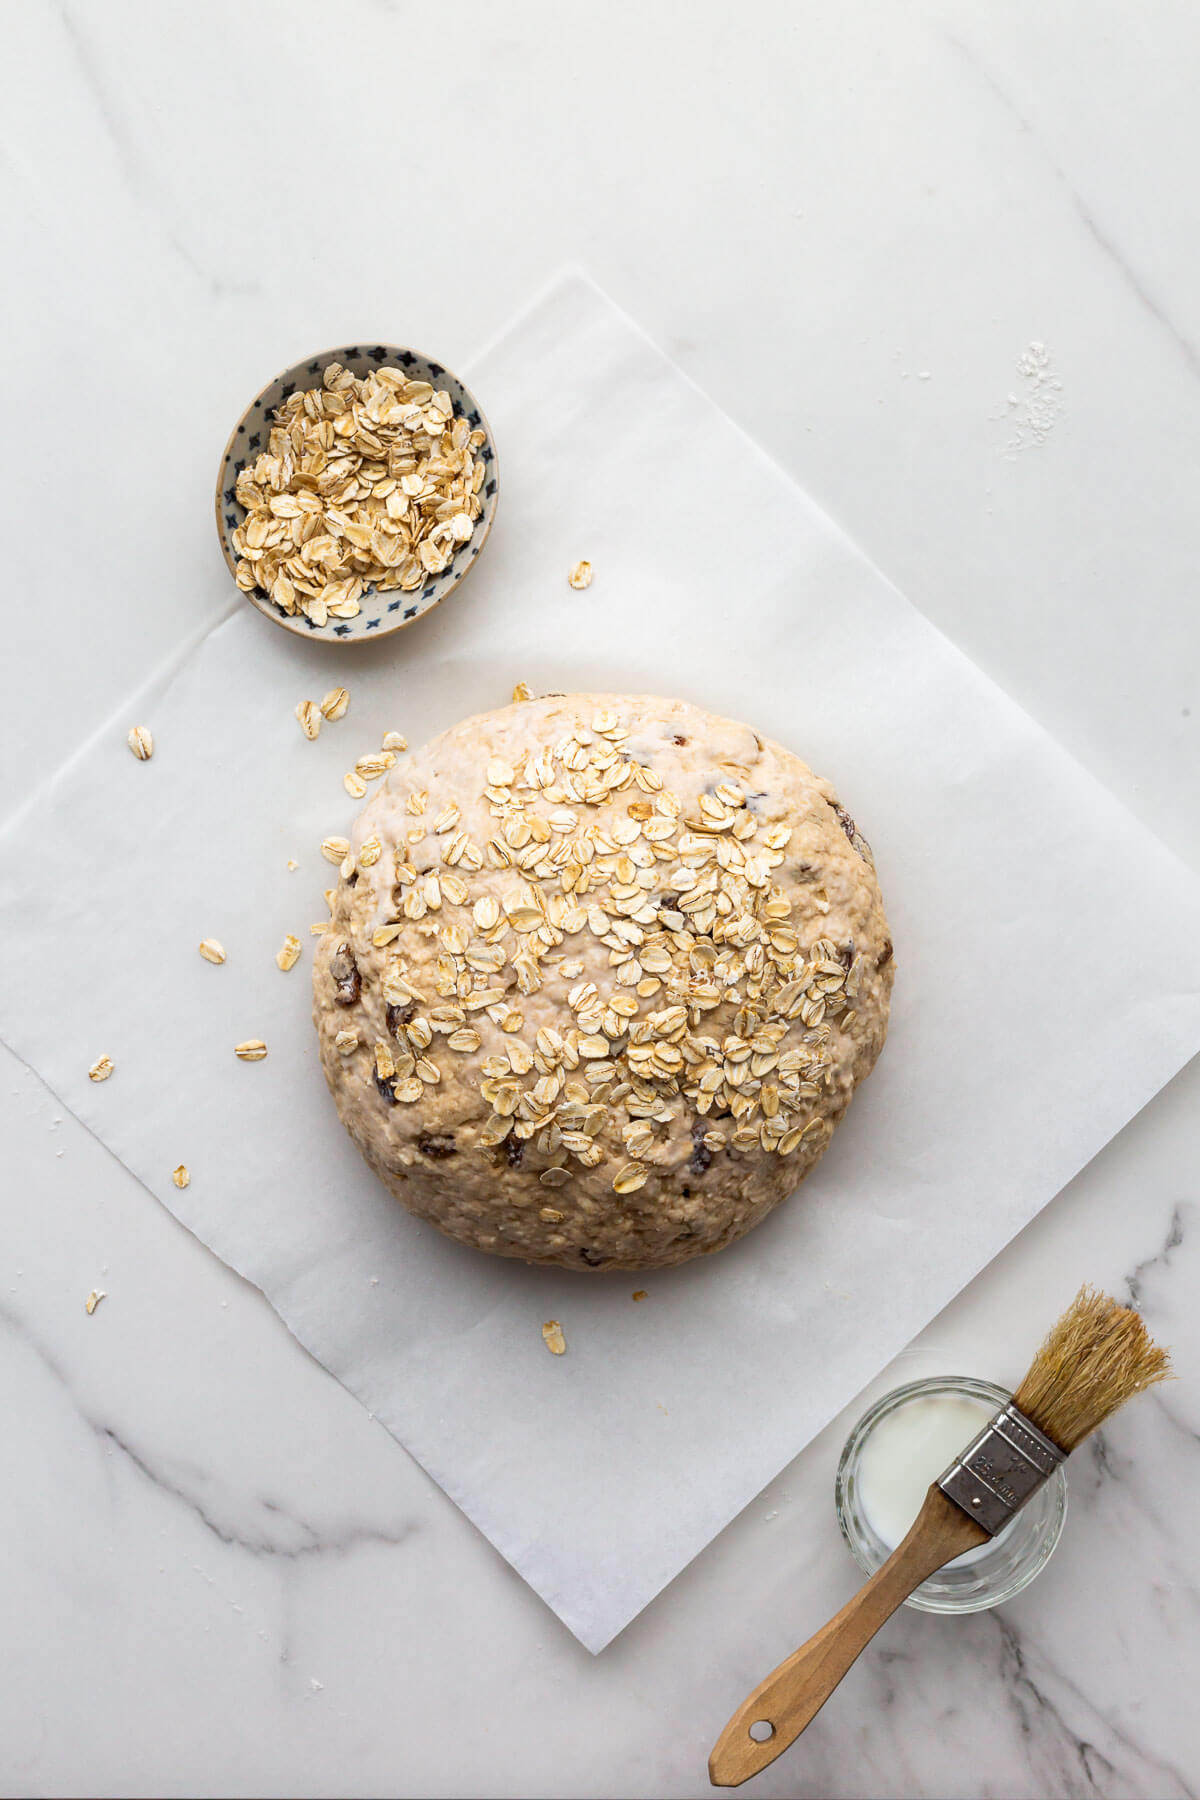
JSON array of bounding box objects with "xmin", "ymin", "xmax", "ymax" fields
[{"xmin": 858, "ymin": 1393, "xmax": 1007, "ymax": 1568}]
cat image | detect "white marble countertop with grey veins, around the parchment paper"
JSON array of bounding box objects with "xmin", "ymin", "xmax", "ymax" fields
[{"xmin": 0, "ymin": 0, "xmax": 1200, "ymax": 1800}]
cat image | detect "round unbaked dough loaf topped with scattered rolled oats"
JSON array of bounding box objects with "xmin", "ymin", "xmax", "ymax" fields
[{"xmin": 313, "ymin": 695, "xmax": 892, "ymax": 1269}]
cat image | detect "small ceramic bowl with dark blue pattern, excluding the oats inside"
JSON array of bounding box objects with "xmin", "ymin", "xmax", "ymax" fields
[{"xmin": 216, "ymin": 344, "xmax": 498, "ymax": 644}]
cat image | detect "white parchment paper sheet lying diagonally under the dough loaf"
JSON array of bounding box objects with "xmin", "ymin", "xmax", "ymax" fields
[{"xmin": 0, "ymin": 275, "xmax": 1200, "ymax": 1651}]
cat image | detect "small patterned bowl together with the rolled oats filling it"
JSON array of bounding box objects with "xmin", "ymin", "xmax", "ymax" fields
[{"xmin": 216, "ymin": 344, "xmax": 497, "ymax": 644}]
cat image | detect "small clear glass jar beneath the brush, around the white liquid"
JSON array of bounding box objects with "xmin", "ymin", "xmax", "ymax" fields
[{"xmin": 833, "ymin": 1375, "xmax": 1067, "ymax": 1613}]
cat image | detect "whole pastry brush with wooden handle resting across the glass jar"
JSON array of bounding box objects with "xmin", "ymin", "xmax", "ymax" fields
[{"xmin": 709, "ymin": 1287, "xmax": 1169, "ymax": 1787}]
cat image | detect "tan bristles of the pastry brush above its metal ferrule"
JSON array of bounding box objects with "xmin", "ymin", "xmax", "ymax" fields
[{"xmin": 1013, "ymin": 1287, "xmax": 1171, "ymax": 1451}]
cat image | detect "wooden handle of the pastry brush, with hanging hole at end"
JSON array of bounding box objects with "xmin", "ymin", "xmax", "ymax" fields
[{"xmin": 709, "ymin": 1485, "xmax": 988, "ymax": 1787}]
